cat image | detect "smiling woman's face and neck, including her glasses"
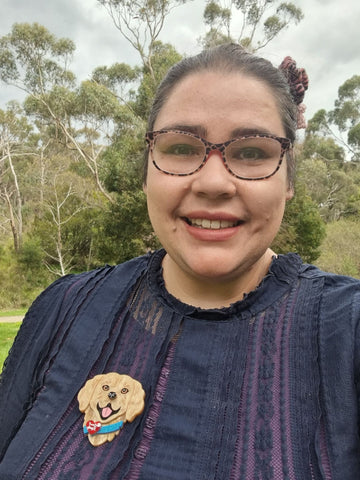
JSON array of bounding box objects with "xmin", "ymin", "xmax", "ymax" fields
[{"xmin": 144, "ymin": 70, "xmax": 292, "ymax": 308}]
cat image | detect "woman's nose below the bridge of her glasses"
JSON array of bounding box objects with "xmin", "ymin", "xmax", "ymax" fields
[{"xmin": 193, "ymin": 150, "xmax": 236, "ymax": 197}]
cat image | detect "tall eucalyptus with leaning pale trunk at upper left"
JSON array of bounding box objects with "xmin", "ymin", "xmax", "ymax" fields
[{"xmin": 0, "ymin": 23, "xmax": 131, "ymax": 202}]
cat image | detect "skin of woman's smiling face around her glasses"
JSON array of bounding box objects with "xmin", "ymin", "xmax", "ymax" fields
[{"xmin": 144, "ymin": 72, "xmax": 292, "ymax": 296}]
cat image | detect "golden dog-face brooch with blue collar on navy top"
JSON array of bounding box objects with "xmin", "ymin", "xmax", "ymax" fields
[{"xmin": 77, "ymin": 372, "xmax": 145, "ymax": 447}]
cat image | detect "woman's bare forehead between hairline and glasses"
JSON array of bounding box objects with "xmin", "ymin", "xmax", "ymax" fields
[{"xmin": 154, "ymin": 71, "xmax": 284, "ymax": 136}]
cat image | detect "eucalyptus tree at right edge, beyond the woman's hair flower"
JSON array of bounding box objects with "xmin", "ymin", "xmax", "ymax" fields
[{"xmin": 300, "ymin": 75, "xmax": 360, "ymax": 222}]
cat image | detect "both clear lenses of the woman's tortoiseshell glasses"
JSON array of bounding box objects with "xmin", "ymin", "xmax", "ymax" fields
[{"xmin": 152, "ymin": 132, "xmax": 282, "ymax": 179}]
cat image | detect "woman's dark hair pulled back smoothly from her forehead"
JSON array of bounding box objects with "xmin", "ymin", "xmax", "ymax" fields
[{"xmin": 144, "ymin": 44, "xmax": 298, "ymax": 185}]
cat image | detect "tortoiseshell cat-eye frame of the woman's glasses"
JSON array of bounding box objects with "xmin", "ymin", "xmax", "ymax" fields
[{"xmin": 145, "ymin": 129, "xmax": 293, "ymax": 181}]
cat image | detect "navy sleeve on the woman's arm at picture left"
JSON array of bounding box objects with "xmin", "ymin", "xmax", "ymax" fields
[{"xmin": 0, "ymin": 275, "xmax": 76, "ymax": 460}]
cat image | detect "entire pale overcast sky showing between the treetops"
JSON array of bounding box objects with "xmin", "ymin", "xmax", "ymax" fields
[{"xmin": 0, "ymin": 0, "xmax": 360, "ymax": 124}]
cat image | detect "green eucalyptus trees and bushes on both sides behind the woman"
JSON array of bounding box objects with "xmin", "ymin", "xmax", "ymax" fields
[{"xmin": 0, "ymin": 14, "xmax": 360, "ymax": 308}]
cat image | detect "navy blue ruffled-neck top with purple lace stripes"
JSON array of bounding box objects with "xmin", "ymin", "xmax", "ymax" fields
[{"xmin": 0, "ymin": 251, "xmax": 360, "ymax": 480}]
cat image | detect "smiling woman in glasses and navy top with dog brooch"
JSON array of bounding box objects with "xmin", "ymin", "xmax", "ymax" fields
[{"xmin": 0, "ymin": 45, "xmax": 360, "ymax": 480}]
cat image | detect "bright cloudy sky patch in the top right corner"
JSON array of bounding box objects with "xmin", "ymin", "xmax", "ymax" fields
[{"xmin": 260, "ymin": 0, "xmax": 360, "ymax": 118}]
